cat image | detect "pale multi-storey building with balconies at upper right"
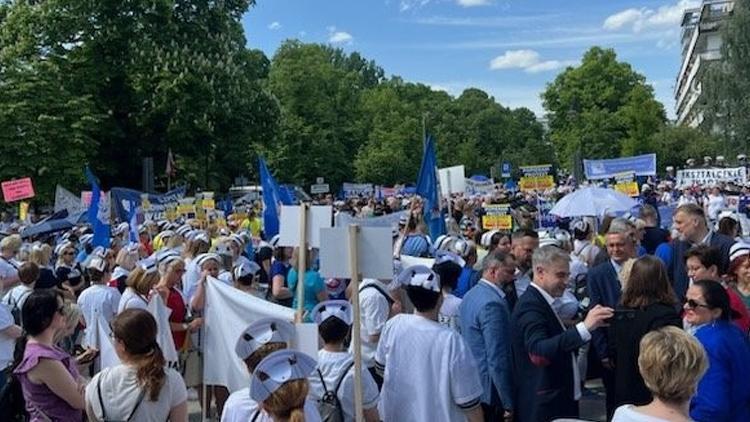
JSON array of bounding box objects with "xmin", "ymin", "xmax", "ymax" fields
[{"xmin": 674, "ymin": 0, "xmax": 734, "ymax": 127}]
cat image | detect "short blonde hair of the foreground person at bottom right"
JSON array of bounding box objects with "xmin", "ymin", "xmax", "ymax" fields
[{"xmin": 638, "ymin": 326, "xmax": 708, "ymax": 404}]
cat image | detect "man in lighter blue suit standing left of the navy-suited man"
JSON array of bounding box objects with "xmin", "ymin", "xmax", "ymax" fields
[{"xmin": 459, "ymin": 251, "xmax": 516, "ymax": 421}]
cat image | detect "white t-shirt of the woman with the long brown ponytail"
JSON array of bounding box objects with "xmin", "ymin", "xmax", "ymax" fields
[{"xmin": 86, "ymin": 365, "xmax": 187, "ymax": 422}]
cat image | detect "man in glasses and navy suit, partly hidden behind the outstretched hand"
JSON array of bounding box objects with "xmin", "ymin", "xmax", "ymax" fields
[{"xmin": 586, "ymin": 225, "xmax": 635, "ymax": 419}]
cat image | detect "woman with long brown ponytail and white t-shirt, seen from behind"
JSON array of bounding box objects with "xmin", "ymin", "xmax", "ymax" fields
[{"xmin": 86, "ymin": 309, "xmax": 187, "ymax": 422}]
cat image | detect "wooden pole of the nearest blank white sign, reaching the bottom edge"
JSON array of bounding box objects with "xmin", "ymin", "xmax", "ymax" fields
[{"xmin": 349, "ymin": 225, "xmax": 364, "ymax": 422}]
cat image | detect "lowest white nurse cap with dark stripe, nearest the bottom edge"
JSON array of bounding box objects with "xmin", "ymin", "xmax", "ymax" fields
[{"xmin": 250, "ymin": 350, "xmax": 316, "ymax": 403}]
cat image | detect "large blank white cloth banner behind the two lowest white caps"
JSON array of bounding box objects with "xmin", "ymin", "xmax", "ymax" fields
[{"xmin": 203, "ymin": 278, "xmax": 300, "ymax": 392}]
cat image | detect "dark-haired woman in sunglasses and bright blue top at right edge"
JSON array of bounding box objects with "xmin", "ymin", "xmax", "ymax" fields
[{"xmin": 684, "ymin": 280, "xmax": 750, "ymax": 422}]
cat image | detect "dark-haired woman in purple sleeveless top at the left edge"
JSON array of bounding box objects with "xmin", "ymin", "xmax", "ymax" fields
[{"xmin": 13, "ymin": 290, "xmax": 85, "ymax": 422}]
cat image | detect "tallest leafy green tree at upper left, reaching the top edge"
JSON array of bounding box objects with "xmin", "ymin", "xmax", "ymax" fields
[{"xmin": 0, "ymin": 0, "xmax": 279, "ymax": 189}]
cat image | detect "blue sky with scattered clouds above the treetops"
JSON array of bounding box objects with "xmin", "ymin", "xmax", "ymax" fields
[{"xmin": 243, "ymin": 0, "xmax": 700, "ymax": 117}]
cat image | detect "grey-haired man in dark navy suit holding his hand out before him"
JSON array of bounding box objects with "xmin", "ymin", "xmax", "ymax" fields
[{"xmin": 511, "ymin": 246, "xmax": 614, "ymax": 422}]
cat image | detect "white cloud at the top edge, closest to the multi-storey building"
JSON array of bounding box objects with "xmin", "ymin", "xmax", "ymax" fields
[{"xmin": 603, "ymin": 0, "xmax": 700, "ymax": 33}]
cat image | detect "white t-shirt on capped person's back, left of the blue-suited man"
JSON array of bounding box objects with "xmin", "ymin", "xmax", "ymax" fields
[{"xmin": 375, "ymin": 314, "xmax": 482, "ymax": 421}]
